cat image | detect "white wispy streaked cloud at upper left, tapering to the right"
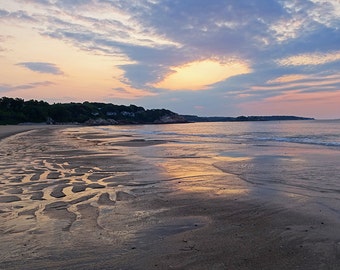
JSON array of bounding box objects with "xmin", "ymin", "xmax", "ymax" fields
[{"xmin": 38, "ymin": 0, "xmax": 180, "ymax": 48}]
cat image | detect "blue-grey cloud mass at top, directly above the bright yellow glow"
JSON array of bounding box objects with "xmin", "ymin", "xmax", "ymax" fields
[{"xmin": 127, "ymin": 0, "xmax": 283, "ymax": 58}]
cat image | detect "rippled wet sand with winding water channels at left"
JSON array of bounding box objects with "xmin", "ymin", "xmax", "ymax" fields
[{"xmin": 0, "ymin": 129, "xmax": 165, "ymax": 261}]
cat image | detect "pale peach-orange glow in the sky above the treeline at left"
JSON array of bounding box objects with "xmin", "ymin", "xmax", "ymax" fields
[{"xmin": 1, "ymin": 23, "xmax": 156, "ymax": 101}]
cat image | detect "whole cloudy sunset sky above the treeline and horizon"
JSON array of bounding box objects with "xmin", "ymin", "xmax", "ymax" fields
[{"xmin": 0, "ymin": 0, "xmax": 340, "ymax": 119}]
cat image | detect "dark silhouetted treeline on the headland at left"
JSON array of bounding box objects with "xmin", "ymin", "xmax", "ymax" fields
[{"xmin": 0, "ymin": 97, "xmax": 186, "ymax": 125}]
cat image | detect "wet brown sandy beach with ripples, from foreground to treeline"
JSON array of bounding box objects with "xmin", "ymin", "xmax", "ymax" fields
[{"xmin": 0, "ymin": 126, "xmax": 340, "ymax": 269}]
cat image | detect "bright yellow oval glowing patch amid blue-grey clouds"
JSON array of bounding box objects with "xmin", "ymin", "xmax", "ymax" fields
[{"xmin": 153, "ymin": 60, "xmax": 252, "ymax": 90}]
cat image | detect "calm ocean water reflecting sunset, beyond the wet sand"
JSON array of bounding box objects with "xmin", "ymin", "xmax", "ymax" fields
[{"xmin": 93, "ymin": 120, "xmax": 340, "ymax": 215}]
